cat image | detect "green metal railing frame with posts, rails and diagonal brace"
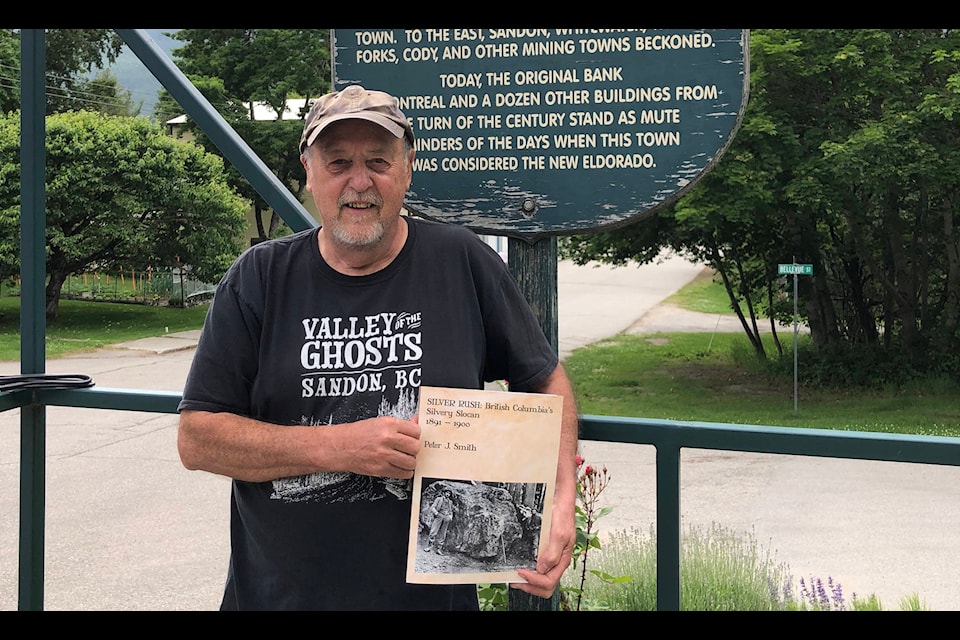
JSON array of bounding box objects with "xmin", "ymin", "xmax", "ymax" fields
[{"xmin": 7, "ymin": 29, "xmax": 960, "ymax": 611}]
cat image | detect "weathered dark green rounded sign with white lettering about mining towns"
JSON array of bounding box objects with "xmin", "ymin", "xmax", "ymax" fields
[{"xmin": 331, "ymin": 29, "xmax": 749, "ymax": 239}]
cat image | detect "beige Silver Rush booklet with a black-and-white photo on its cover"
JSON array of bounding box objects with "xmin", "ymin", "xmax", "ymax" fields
[{"xmin": 407, "ymin": 387, "xmax": 563, "ymax": 584}]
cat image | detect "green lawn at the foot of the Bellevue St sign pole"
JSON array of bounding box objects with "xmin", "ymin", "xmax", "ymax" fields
[{"xmin": 565, "ymin": 333, "xmax": 960, "ymax": 436}]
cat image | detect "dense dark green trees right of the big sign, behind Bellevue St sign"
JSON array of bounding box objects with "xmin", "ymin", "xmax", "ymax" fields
[{"xmin": 568, "ymin": 29, "xmax": 960, "ymax": 372}]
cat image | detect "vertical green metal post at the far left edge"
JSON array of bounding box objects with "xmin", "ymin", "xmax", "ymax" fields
[{"xmin": 19, "ymin": 29, "xmax": 46, "ymax": 611}]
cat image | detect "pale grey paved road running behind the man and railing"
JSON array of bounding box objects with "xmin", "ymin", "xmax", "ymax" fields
[{"xmin": 0, "ymin": 258, "xmax": 960, "ymax": 610}]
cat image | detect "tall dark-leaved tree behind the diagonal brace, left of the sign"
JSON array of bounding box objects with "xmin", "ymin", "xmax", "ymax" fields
[{"xmin": 157, "ymin": 29, "xmax": 330, "ymax": 239}]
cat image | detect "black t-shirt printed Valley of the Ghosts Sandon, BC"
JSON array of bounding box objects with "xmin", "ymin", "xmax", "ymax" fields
[{"xmin": 180, "ymin": 218, "xmax": 558, "ymax": 610}]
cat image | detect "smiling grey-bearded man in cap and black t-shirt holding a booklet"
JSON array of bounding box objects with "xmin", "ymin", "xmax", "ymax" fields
[{"xmin": 178, "ymin": 86, "xmax": 577, "ymax": 610}]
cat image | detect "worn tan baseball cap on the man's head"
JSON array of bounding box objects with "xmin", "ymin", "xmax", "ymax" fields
[{"xmin": 300, "ymin": 84, "xmax": 413, "ymax": 154}]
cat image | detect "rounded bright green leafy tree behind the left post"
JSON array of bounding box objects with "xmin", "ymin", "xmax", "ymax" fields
[{"xmin": 0, "ymin": 111, "xmax": 249, "ymax": 320}]
